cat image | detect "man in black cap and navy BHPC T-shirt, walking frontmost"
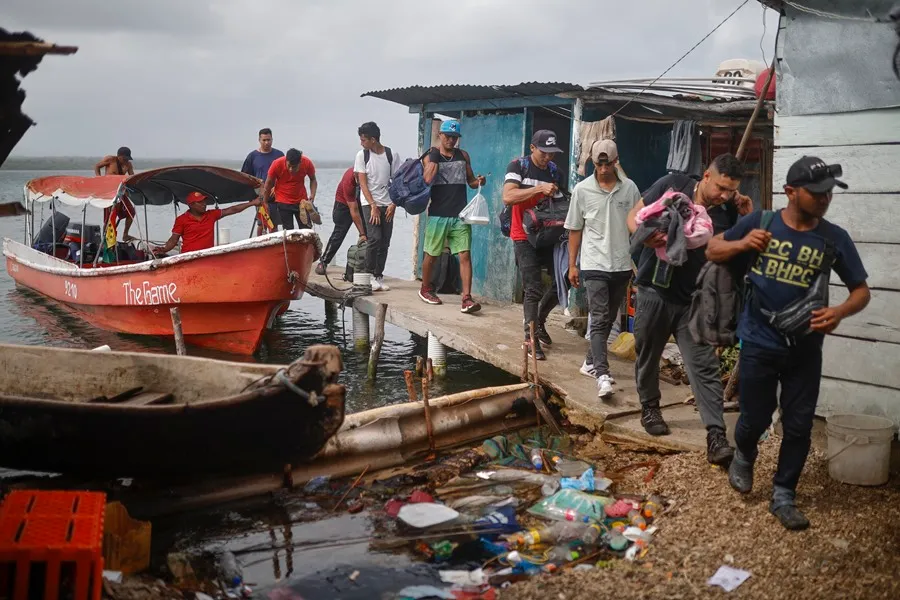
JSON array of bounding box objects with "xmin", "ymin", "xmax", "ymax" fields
[{"xmin": 706, "ymin": 156, "xmax": 870, "ymax": 530}]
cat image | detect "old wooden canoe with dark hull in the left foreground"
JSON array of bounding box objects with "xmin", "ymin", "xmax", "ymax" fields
[{"xmin": 0, "ymin": 345, "xmax": 345, "ymax": 479}]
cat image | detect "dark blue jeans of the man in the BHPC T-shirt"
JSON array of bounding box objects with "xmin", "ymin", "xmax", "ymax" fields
[{"xmin": 734, "ymin": 336, "xmax": 822, "ymax": 490}]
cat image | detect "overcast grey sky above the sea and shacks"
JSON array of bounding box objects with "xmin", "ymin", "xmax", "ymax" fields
[{"xmin": 0, "ymin": 0, "xmax": 778, "ymax": 166}]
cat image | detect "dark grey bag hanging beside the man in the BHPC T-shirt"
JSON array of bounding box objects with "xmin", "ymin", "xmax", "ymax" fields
[{"xmin": 688, "ymin": 210, "xmax": 775, "ymax": 346}]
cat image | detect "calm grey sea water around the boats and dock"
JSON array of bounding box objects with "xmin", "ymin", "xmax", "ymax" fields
[{"xmin": 0, "ymin": 163, "xmax": 514, "ymax": 412}]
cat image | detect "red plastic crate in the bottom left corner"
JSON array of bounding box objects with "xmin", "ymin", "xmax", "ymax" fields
[{"xmin": 0, "ymin": 490, "xmax": 106, "ymax": 600}]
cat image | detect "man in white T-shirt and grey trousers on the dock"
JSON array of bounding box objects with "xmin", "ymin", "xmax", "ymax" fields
[{"xmin": 353, "ymin": 122, "xmax": 403, "ymax": 292}]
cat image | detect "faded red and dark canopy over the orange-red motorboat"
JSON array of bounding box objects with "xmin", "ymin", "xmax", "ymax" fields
[{"xmin": 25, "ymin": 165, "xmax": 262, "ymax": 208}]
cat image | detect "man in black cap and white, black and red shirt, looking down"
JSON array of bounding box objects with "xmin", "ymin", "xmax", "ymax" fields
[{"xmin": 503, "ymin": 129, "xmax": 563, "ymax": 360}]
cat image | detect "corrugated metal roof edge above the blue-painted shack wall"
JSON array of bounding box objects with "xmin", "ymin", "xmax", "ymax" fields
[{"xmin": 362, "ymin": 81, "xmax": 584, "ymax": 106}]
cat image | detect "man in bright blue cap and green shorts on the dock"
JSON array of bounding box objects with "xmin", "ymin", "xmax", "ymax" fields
[{"xmin": 419, "ymin": 119, "xmax": 485, "ymax": 314}]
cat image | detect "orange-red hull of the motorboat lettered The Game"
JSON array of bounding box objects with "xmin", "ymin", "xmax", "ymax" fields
[{"xmin": 4, "ymin": 232, "xmax": 320, "ymax": 355}]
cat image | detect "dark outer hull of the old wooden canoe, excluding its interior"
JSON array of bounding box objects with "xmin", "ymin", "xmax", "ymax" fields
[{"xmin": 0, "ymin": 344, "xmax": 344, "ymax": 479}]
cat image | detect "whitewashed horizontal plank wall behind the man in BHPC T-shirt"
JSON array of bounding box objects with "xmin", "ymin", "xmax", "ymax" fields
[{"xmin": 773, "ymin": 108, "xmax": 900, "ymax": 424}]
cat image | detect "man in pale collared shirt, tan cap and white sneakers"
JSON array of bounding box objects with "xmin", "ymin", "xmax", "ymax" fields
[{"xmin": 566, "ymin": 140, "xmax": 641, "ymax": 398}]
